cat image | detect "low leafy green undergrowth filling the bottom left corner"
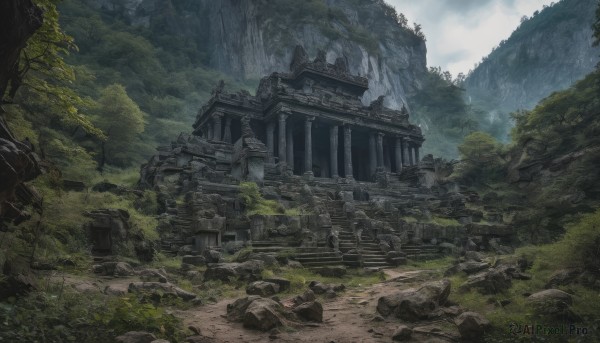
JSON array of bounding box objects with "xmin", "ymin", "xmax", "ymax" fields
[{"xmin": 0, "ymin": 289, "xmax": 184, "ymax": 343}]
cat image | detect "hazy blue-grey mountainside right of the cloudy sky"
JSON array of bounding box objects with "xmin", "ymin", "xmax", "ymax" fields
[{"xmin": 465, "ymin": 0, "xmax": 600, "ymax": 114}]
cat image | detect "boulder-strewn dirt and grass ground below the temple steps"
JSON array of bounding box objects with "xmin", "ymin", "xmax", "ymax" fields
[{"xmin": 42, "ymin": 252, "xmax": 596, "ymax": 343}]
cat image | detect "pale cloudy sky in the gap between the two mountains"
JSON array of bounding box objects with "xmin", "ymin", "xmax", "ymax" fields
[{"xmin": 387, "ymin": 0, "xmax": 558, "ymax": 76}]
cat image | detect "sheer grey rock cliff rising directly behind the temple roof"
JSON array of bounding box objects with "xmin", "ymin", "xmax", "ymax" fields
[{"xmin": 88, "ymin": 0, "xmax": 427, "ymax": 108}]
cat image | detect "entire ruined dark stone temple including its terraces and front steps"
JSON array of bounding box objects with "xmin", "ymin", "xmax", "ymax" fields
[{"xmin": 140, "ymin": 47, "xmax": 509, "ymax": 267}]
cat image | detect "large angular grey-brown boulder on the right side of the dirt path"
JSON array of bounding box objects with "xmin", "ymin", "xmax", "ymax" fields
[{"xmin": 377, "ymin": 279, "xmax": 450, "ymax": 322}]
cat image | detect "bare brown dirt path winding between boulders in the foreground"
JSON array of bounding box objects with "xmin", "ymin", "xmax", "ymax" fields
[{"xmin": 175, "ymin": 269, "xmax": 451, "ymax": 343}]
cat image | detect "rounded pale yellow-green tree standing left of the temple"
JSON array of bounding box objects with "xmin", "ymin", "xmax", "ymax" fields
[{"xmin": 96, "ymin": 84, "xmax": 145, "ymax": 171}]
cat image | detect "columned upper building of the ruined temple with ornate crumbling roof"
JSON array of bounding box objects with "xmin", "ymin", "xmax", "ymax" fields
[{"xmin": 193, "ymin": 46, "xmax": 424, "ymax": 182}]
